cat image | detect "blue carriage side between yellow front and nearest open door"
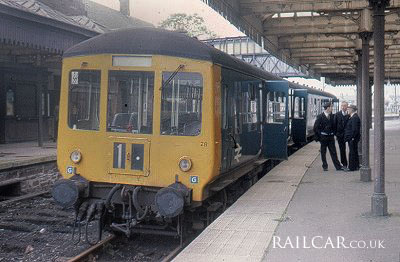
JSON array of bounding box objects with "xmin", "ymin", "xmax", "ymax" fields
[{"xmin": 221, "ymin": 75, "xmax": 261, "ymax": 171}]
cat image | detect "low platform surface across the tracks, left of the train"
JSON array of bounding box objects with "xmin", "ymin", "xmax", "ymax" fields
[{"xmin": 0, "ymin": 142, "xmax": 57, "ymax": 170}]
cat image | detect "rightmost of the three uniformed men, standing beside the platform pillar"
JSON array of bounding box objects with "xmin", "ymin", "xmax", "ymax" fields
[{"xmin": 344, "ymin": 105, "xmax": 361, "ymax": 171}]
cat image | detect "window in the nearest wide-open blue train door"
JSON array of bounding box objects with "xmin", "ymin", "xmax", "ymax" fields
[{"xmin": 266, "ymin": 92, "xmax": 286, "ymax": 124}]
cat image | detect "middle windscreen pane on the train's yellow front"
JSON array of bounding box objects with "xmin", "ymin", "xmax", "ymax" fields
[{"xmin": 107, "ymin": 71, "xmax": 154, "ymax": 134}]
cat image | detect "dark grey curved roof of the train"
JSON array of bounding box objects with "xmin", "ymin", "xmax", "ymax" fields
[{"xmin": 64, "ymin": 27, "xmax": 335, "ymax": 98}]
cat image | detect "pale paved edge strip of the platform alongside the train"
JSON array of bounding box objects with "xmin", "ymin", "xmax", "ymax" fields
[{"xmin": 174, "ymin": 143, "xmax": 318, "ymax": 262}]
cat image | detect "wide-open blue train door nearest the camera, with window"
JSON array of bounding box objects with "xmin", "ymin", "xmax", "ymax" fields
[{"xmin": 262, "ymin": 81, "xmax": 289, "ymax": 159}]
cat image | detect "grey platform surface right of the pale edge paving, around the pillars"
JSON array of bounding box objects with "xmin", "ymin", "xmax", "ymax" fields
[{"xmin": 263, "ymin": 120, "xmax": 400, "ymax": 262}]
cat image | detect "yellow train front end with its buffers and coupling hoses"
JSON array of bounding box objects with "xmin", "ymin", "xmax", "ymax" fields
[{"xmin": 53, "ymin": 54, "xmax": 221, "ymax": 237}]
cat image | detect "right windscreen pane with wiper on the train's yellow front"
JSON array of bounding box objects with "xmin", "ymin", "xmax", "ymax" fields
[{"xmin": 161, "ymin": 72, "xmax": 203, "ymax": 136}]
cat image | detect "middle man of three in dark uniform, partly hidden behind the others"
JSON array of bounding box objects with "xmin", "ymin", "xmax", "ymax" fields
[{"xmin": 335, "ymin": 102, "xmax": 349, "ymax": 169}]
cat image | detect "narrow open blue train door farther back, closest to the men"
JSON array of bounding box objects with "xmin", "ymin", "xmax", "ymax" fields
[{"xmin": 291, "ymin": 89, "xmax": 308, "ymax": 144}]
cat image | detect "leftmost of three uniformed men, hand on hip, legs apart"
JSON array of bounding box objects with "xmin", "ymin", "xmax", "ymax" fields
[{"xmin": 314, "ymin": 103, "xmax": 343, "ymax": 171}]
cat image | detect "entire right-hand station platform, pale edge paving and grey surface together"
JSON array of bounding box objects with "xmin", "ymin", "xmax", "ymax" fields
[{"xmin": 174, "ymin": 120, "xmax": 400, "ymax": 262}]
